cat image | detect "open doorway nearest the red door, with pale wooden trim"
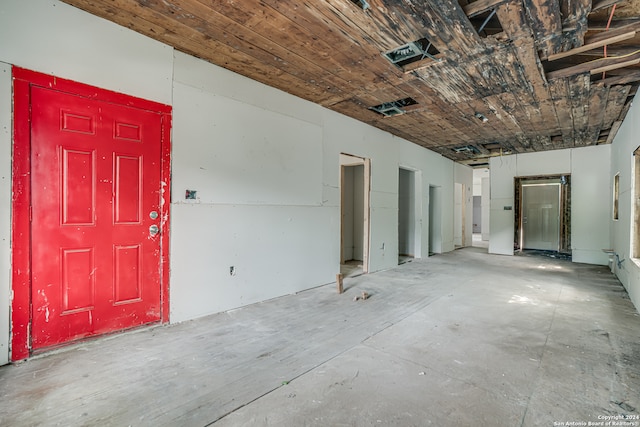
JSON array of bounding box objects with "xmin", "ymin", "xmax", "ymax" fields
[{"xmin": 340, "ymin": 154, "xmax": 370, "ymax": 277}]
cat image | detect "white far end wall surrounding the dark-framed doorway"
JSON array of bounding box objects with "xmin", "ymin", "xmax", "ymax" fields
[{"xmin": 489, "ymin": 149, "xmax": 611, "ymax": 265}]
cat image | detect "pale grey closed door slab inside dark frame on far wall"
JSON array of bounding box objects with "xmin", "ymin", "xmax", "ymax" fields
[{"xmin": 522, "ymin": 183, "xmax": 560, "ymax": 251}]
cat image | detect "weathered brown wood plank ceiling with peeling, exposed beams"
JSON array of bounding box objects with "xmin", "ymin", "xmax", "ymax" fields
[{"xmin": 63, "ymin": 0, "xmax": 640, "ymax": 166}]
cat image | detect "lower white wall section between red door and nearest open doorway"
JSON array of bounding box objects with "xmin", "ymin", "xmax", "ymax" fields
[{"xmin": 170, "ymin": 204, "xmax": 340, "ymax": 322}]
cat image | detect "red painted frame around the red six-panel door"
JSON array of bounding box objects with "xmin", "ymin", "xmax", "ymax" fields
[{"xmin": 11, "ymin": 66, "xmax": 172, "ymax": 361}]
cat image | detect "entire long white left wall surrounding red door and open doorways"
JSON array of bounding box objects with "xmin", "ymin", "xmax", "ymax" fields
[{"xmin": 0, "ymin": 0, "xmax": 454, "ymax": 363}]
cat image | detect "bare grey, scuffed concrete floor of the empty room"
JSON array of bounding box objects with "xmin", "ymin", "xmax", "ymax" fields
[{"xmin": 0, "ymin": 248, "xmax": 640, "ymax": 426}]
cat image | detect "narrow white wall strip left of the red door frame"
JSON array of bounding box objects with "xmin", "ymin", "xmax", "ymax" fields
[{"xmin": 0, "ymin": 62, "xmax": 12, "ymax": 365}]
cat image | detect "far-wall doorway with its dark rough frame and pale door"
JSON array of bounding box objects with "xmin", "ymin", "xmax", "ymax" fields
[{"xmin": 514, "ymin": 175, "xmax": 571, "ymax": 257}]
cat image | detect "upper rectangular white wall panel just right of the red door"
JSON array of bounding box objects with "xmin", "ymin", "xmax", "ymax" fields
[{"xmin": 172, "ymin": 83, "xmax": 322, "ymax": 205}]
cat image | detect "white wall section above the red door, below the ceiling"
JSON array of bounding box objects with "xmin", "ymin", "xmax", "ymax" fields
[{"xmin": 0, "ymin": 0, "xmax": 173, "ymax": 104}]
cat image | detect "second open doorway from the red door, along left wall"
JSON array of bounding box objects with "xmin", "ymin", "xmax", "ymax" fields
[{"xmin": 398, "ymin": 168, "xmax": 422, "ymax": 264}]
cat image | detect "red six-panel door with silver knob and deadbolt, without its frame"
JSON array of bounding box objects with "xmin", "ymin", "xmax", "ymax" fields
[{"xmin": 30, "ymin": 86, "xmax": 162, "ymax": 349}]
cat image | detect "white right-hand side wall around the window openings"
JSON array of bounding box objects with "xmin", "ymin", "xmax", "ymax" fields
[{"xmin": 606, "ymin": 103, "xmax": 640, "ymax": 311}]
